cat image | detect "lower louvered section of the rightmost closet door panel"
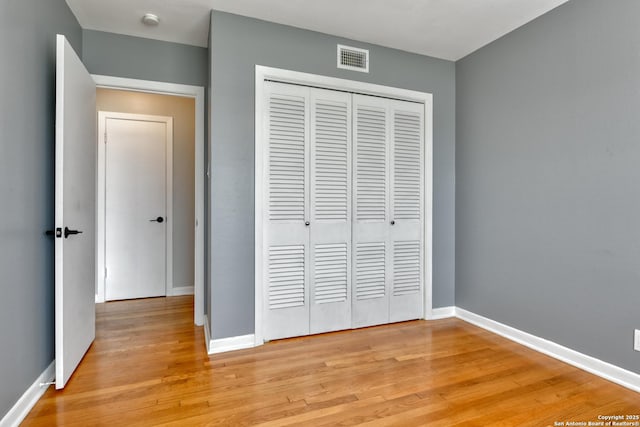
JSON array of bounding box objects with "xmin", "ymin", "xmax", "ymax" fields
[{"xmin": 393, "ymin": 241, "xmax": 420, "ymax": 296}]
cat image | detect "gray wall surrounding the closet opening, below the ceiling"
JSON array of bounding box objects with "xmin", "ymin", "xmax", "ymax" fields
[{"xmin": 209, "ymin": 11, "xmax": 455, "ymax": 338}]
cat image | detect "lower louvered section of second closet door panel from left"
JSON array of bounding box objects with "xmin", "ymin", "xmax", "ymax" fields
[{"xmin": 314, "ymin": 243, "xmax": 347, "ymax": 304}]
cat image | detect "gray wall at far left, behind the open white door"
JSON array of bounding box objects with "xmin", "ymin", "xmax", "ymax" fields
[{"xmin": 0, "ymin": 0, "xmax": 82, "ymax": 419}]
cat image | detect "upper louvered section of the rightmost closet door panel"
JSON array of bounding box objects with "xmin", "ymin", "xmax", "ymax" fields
[{"xmin": 393, "ymin": 111, "xmax": 422, "ymax": 220}]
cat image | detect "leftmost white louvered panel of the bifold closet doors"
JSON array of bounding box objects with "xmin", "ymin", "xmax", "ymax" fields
[{"xmin": 263, "ymin": 82, "xmax": 310, "ymax": 340}]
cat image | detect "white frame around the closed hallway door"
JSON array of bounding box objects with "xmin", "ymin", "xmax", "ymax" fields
[{"xmin": 96, "ymin": 111, "xmax": 174, "ymax": 300}]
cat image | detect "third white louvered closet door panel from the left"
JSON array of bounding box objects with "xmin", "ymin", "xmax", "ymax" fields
[{"xmin": 352, "ymin": 95, "xmax": 392, "ymax": 328}]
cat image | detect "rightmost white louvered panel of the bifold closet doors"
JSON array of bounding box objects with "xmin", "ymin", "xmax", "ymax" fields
[{"xmin": 389, "ymin": 101, "xmax": 424, "ymax": 322}]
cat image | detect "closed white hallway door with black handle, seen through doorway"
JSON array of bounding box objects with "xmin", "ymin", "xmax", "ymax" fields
[{"xmin": 100, "ymin": 112, "xmax": 173, "ymax": 300}]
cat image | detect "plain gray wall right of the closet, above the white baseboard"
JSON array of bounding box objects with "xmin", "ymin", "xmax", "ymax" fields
[{"xmin": 456, "ymin": 0, "xmax": 640, "ymax": 373}]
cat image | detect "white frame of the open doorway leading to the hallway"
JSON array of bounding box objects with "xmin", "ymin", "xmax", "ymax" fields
[{"xmin": 92, "ymin": 74, "xmax": 205, "ymax": 326}]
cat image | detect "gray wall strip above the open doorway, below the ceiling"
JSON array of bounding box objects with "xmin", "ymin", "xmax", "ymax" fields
[{"xmin": 82, "ymin": 30, "xmax": 209, "ymax": 86}]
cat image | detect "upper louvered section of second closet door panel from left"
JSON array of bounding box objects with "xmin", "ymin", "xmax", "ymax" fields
[{"xmin": 314, "ymin": 102, "xmax": 349, "ymax": 221}]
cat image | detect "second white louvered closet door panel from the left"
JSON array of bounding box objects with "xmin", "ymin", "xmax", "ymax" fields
[{"xmin": 309, "ymin": 89, "xmax": 351, "ymax": 334}]
